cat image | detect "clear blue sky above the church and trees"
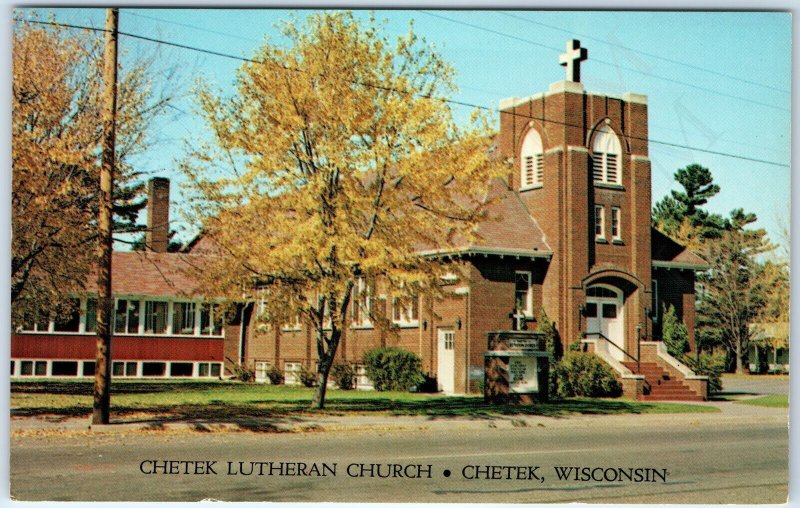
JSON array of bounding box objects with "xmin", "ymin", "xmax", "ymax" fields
[{"xmin": 15, "ymin": 8, "xmax": 792, "ymax": 250}]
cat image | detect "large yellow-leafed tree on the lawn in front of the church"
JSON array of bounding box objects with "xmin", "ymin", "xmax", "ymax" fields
[{"xmin": 185, "ymin": 13, "xmax": 498, "ymax": 408}]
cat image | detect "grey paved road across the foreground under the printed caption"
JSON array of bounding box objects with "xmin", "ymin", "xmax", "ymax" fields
[{"xmin": 11, "ymin": 403, "xmax": 788, "ymax": 503}]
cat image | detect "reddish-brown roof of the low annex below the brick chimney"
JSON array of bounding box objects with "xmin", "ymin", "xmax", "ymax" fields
[{"xmin": 86, "ymin": 251, "xmax": 204, "ymax": 297}]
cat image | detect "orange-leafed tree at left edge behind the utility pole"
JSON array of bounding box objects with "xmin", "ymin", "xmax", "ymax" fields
[{"xmin": 11, "ymin": 16, "xmax": 169, "ymax": 324}]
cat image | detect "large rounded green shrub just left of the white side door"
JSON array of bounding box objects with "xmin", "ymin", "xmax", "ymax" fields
[{"xmin": 364, "ymin": 348, "xmax": 425, "ymax": 391}]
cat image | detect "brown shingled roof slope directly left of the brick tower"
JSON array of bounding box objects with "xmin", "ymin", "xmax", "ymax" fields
[{"xmin": 420, "ymin": 178, "xmax": 553, "ymax": 258}]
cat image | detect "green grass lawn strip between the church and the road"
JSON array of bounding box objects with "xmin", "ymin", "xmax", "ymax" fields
[{"xmin": 11, "ymin": 381, "xmax": 718, "ymax": 424}]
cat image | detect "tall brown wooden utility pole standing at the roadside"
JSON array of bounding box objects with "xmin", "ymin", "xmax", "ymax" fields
[{"xmin": 92, "ymin": 9, "xmax": 119, "ymax": 424}]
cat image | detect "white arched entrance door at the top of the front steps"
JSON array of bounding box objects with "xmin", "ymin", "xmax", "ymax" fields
[{"xmin": 586, "ymin": 286, "xmax": 627, "ymax": 361}]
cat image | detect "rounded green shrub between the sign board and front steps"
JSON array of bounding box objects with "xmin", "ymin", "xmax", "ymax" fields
[{"xmin": 554, "ymin": 352, "xmax": 622, "ymax": 397}]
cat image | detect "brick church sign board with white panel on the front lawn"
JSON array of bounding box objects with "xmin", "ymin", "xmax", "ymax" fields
[{"xmin": 484, "ymin": 331, "xmax": 550, "ymax": 404}]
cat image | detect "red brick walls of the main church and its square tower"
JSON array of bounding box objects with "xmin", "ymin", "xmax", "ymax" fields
[{"xmin": 244, "ymin": 82, "xmax": 702, "ymax": 393}]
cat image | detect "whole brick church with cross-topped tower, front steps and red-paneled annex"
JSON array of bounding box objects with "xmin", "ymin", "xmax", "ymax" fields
[{"xmin": 12, "ymin": 41, "xmax": 706, "ymax": 399}]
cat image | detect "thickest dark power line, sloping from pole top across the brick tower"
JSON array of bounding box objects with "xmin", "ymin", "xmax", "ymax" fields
[{"xmin": 14, "ymin": 18, "xmax": 789, "ymax": 168}]
